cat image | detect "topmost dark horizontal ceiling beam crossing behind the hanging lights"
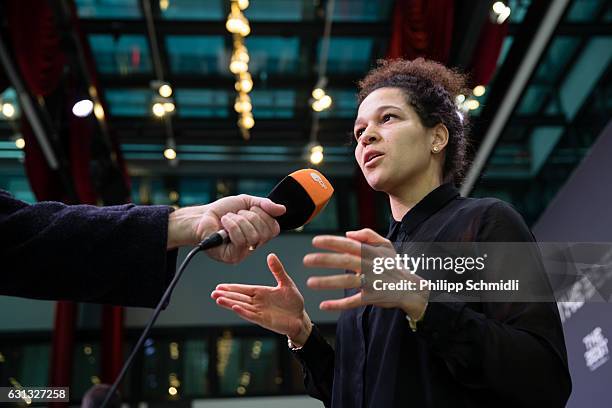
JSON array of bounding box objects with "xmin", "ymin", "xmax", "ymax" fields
[{"xmin": 80, "ymin": 18, "xmax": 391, "ymax": 38}]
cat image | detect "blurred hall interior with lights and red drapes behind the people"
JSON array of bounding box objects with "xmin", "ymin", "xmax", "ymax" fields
[{"xmin": 0, "ymin": 0, "xmax": 612, "ymax": 407}]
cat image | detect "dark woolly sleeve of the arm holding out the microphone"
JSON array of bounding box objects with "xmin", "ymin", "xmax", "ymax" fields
[{"xmin": 0, "ymin": 190, "xmax": 178, "ymax": 307}]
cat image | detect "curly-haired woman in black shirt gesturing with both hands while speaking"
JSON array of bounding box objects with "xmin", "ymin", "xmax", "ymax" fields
[{"xmin": 212, "ymin": 59, "xmax": 571, "ymax": 408}]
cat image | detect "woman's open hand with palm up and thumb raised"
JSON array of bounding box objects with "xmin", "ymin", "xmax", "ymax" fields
[{"xmin": 211, "ymin": 254, "xmax": 312, "ymax": 347}]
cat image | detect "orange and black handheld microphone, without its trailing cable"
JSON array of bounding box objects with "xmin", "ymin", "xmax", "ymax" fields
[{"xmin": 198, "ymin": 169, "xmax": 334, "ymax": 249}]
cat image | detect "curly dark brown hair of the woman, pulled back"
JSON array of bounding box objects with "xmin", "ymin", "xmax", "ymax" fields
[{"xmin": 357, "ymin": 58, "xmax": 469, "ymax": 184}]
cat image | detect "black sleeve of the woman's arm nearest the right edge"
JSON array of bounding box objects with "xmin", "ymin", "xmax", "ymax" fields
[{"xmin": 417, "ymin": 202, "xmax": 571, "ymax": 408}]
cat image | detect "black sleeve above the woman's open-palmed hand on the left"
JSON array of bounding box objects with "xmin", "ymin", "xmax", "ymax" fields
[{"xmin": 293, "ymin": 326, "xmax": 334, "ymax": 407}]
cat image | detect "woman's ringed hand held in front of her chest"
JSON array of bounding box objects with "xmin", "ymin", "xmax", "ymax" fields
[{"xmin": 304, "ymin": 228, "xmax": 429, "ymax": 319}]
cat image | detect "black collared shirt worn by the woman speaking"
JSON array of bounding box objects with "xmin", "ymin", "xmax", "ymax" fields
[{"xmin": 294, "ymin": 184, "xmax": 571, "ymax": 408}]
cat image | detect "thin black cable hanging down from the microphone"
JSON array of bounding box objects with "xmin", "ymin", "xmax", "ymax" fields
[{"xmin": 100, "ymin": 230, "xmax": 228, "ymax": 408}]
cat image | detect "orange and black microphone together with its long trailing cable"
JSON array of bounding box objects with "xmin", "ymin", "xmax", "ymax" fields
[{"xmin": 95, "ymin": 169, "xmax": 334, "ymax": 408}]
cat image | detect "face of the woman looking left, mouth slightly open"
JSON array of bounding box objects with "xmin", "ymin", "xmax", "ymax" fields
[{"xmin": 353, "ymin": 88, "xmax": 437, "ymax": 195}]
